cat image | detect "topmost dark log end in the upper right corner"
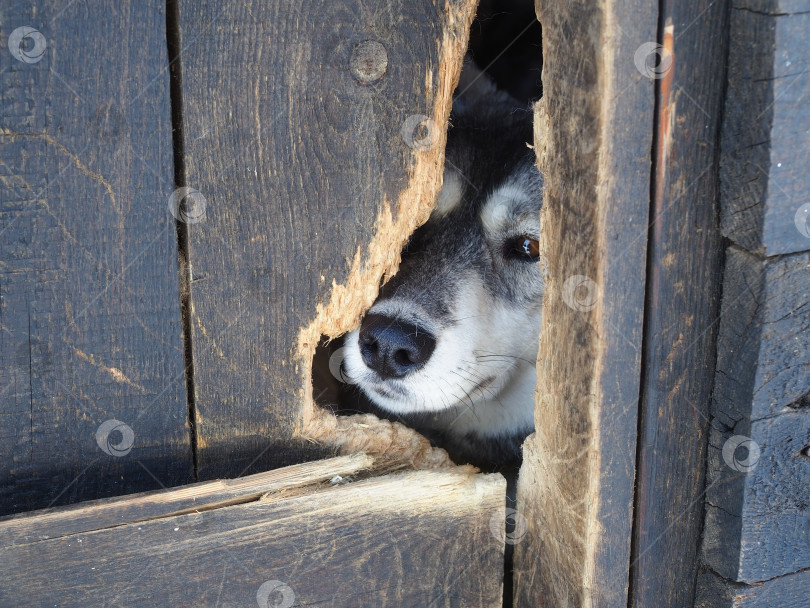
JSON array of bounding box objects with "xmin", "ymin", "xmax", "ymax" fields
[{"xmin": 720, "ymin": 0, "xmax": 810, "ymax": 255}]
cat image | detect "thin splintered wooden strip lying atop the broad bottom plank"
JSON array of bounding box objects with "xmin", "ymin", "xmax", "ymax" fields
[{"xmin": 0, "ymin": 454, "xmax": 374, "ymax": 546}]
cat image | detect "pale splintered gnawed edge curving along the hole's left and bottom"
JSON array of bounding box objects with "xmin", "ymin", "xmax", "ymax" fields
[{"xmin": 295, "ymin": 0, "xmax": 477, "ymax": 470}]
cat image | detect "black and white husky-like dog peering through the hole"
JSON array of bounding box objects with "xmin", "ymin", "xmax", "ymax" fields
[{"xmin": 342, "ymin": 59, "xmax": 544, "ymax": 469}]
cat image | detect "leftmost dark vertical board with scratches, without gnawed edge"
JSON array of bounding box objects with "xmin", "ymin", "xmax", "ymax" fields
[{"xmin": 0, "ymin": 1, "xmax": 191, "ymax": 513}]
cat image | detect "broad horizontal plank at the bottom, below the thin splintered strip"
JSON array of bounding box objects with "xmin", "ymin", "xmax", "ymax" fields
[{"xmin": 0, "ymin": 471, "xmax": 505, "ymax": 608}]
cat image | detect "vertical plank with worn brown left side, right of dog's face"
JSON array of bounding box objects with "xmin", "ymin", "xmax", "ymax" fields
[{"xmin": 515, "ymin": 0, "xmax": 657, "ymax": 606}]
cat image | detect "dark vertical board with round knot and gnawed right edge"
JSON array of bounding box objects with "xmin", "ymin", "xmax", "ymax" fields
[{"xmin": 179, "ymin": 0, "xmax": 474, "ymax": 478}]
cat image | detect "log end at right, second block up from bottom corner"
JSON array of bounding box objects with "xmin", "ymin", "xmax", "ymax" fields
[{"xmin": 703, "ymin": 408, "xmax": 810, "ymax": 583}]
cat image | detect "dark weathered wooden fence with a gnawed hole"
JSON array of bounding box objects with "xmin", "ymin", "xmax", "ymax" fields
[{"xmin": 0, "ymin": 0, "xmax": 810, "ymax": 608}]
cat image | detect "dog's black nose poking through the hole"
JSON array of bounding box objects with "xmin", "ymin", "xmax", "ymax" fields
[{"xmin": 360, "ymin": 314, "xmax": 436, "ymax": 379}]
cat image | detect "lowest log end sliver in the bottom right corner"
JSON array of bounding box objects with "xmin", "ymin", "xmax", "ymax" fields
[{"xmin": 695, "ymin": 572, "xmax": 810, "ymax": 608}]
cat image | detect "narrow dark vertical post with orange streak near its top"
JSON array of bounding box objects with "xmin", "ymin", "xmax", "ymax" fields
[{"xmin": 630, "ymin": 0, "xmax": 728, "ymax": 608}]
